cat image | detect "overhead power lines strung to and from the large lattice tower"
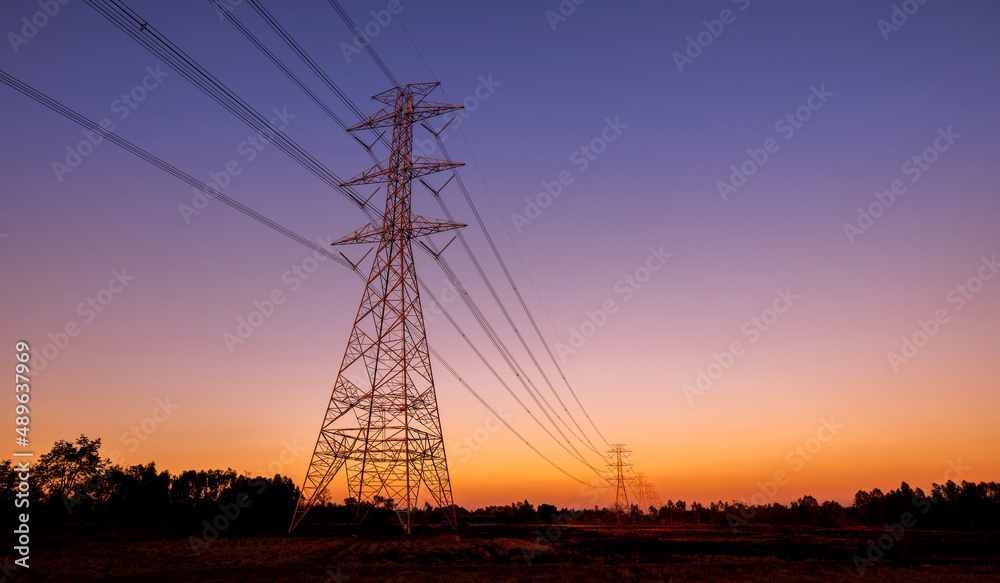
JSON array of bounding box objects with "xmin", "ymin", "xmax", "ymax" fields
[{"xmin": 0, "ymin": 0, "xmax": 624, "ymax": 484}]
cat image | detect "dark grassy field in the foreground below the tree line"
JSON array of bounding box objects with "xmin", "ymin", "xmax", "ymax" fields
[{"xmin": 12, "ymin": 524, "xmax": 1000, "ymax": 583}]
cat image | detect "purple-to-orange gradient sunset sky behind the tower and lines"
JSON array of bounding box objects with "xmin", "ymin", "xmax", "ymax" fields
[{"xmin": 0, "ymin": 0, "xmax": 1000, "ymax": 507}]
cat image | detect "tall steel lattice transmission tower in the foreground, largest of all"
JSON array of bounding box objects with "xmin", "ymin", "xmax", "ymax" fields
[{"xmin": 289, "ymin": 83, "xmax": 465, "ymax": 534}]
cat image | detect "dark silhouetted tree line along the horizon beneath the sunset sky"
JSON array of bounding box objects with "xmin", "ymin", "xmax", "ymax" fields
[{"xmin": 0, "ymin": 435, "xmax": 1000, "ymax": 537}]
